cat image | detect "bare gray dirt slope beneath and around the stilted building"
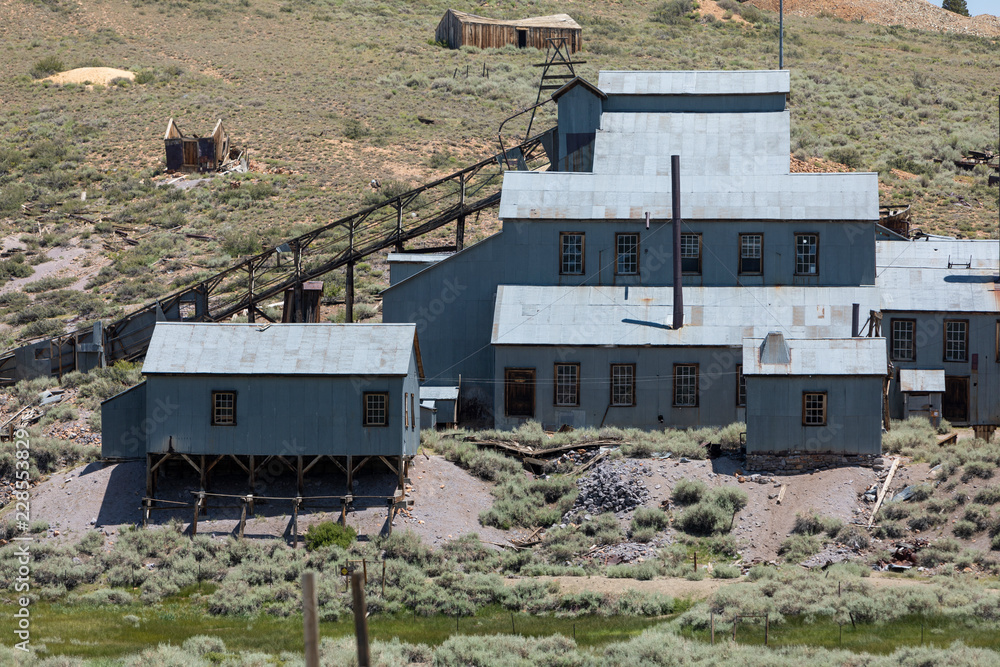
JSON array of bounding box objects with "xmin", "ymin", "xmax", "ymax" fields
[{"xmin": 25, "ymin": 456, "xmax": 510, "ymax": 546}]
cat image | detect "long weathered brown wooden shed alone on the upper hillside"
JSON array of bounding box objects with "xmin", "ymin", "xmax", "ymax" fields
[{"xmin": 434, "ymin": 9, "xmax": 582, "ymax": 53}]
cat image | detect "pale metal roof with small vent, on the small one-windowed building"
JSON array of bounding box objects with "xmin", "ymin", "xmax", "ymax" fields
[{"xmin": 743, "ymin": 336, "xmax": 888, "ymax": 376}]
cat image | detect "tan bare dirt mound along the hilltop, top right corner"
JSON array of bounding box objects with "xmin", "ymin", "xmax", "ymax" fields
[{"xmin": 748, "ymin": 0, "xmax": 1000, "ymax": 37}]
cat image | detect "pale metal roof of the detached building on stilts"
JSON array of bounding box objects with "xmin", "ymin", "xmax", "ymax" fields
[{"xmin": 142, "ymin": 322, "xmax": 420, "ymax": 376}]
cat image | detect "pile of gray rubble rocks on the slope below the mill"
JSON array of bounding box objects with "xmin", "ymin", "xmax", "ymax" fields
[{"xmin": 563, "ymin": 461, "xmax": 653, "ymax": 521}]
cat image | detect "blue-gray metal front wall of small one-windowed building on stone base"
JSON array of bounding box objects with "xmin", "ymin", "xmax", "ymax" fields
[{"xmin": 747, "ymin": 376, "xmax": 882, "ymax": 454}]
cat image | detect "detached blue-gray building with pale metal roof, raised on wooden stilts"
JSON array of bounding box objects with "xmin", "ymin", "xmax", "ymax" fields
[{"xmin": 101, "ymin": 322, "xmax": 421, "ymax": 496}]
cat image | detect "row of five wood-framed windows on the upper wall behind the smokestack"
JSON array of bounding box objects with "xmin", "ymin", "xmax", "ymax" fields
[{"xmin": 559, "ymin": 232, "xmax": 819, "ymax": 276}]
